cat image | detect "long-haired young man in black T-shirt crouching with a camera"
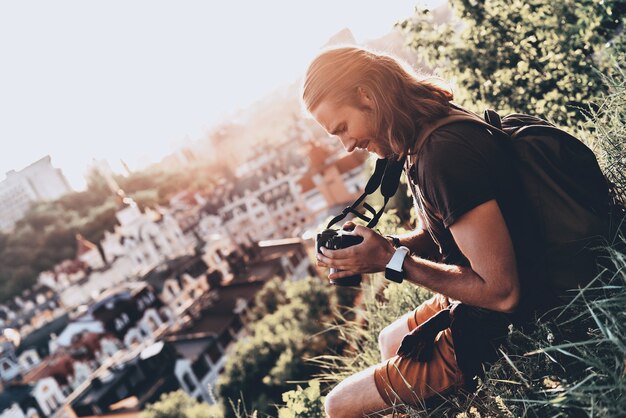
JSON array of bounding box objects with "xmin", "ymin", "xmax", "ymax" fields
[{"xmin": 302, "ymin": 47, "xmax": 539, "ymax": 417}]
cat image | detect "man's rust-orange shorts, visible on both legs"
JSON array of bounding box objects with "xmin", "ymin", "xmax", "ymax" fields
[{"xmin": 374, "ymin": 295, "xmax": 463, "ymax": 406}]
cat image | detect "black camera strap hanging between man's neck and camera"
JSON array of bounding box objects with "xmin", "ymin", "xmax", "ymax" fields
[{"xmin": 326, "ymin": 158, "xmax": 405, "ymax": 229}]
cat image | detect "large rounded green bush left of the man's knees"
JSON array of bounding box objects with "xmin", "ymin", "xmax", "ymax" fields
[{"xmin": 217, "ymin": 278, "xmax": 341, "ymax": 417}]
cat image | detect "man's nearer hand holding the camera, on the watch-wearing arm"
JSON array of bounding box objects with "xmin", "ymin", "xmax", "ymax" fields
[{"xmin": 317, "ymin": 225, "xmax": 395, "ymax": 280}]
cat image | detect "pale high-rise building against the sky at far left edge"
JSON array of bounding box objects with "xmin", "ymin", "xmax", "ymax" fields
[{"xmin": 0, "ymin": 155, "xmax": 72, "ymax": 231}]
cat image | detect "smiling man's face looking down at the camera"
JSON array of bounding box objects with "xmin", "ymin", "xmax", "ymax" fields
[{"xmin": 311, "ymin": 99, "xmax": 385, "ymax": 158}]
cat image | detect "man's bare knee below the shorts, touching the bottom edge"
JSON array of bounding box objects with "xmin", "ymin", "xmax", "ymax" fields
[{"xmin": 324, "ymin": 366, "xmax": 389, "ymax": 418}]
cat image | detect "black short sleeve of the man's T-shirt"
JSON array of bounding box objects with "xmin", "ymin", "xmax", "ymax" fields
[{"xmin": 417, "ymin": 124, "xmax": 503, "ymax": 228}]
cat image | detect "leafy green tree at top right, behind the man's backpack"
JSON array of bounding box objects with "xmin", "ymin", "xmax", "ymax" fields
[{"xmin": 400, "ymin": 0, "xmax": 626, "ymax": 128}]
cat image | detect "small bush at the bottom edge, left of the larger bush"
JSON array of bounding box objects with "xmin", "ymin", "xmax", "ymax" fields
[{"xmin": 139, "ymin": 390, "xmax": 217, "ymax": 418}]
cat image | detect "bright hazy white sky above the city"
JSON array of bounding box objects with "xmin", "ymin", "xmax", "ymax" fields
[{"xmin": 0, "ymin": 0, "xmax": 438, "ymax": 190}]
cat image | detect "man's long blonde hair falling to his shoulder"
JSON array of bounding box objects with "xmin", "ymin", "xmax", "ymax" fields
[{"xmin": 302, "ymin": 46, "xmax": 453, "ymax": 158}]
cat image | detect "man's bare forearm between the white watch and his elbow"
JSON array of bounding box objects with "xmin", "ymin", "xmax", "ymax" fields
[{"xmin": 403, "ymin": 257, "xmax": 518, "ymax": 312}]
